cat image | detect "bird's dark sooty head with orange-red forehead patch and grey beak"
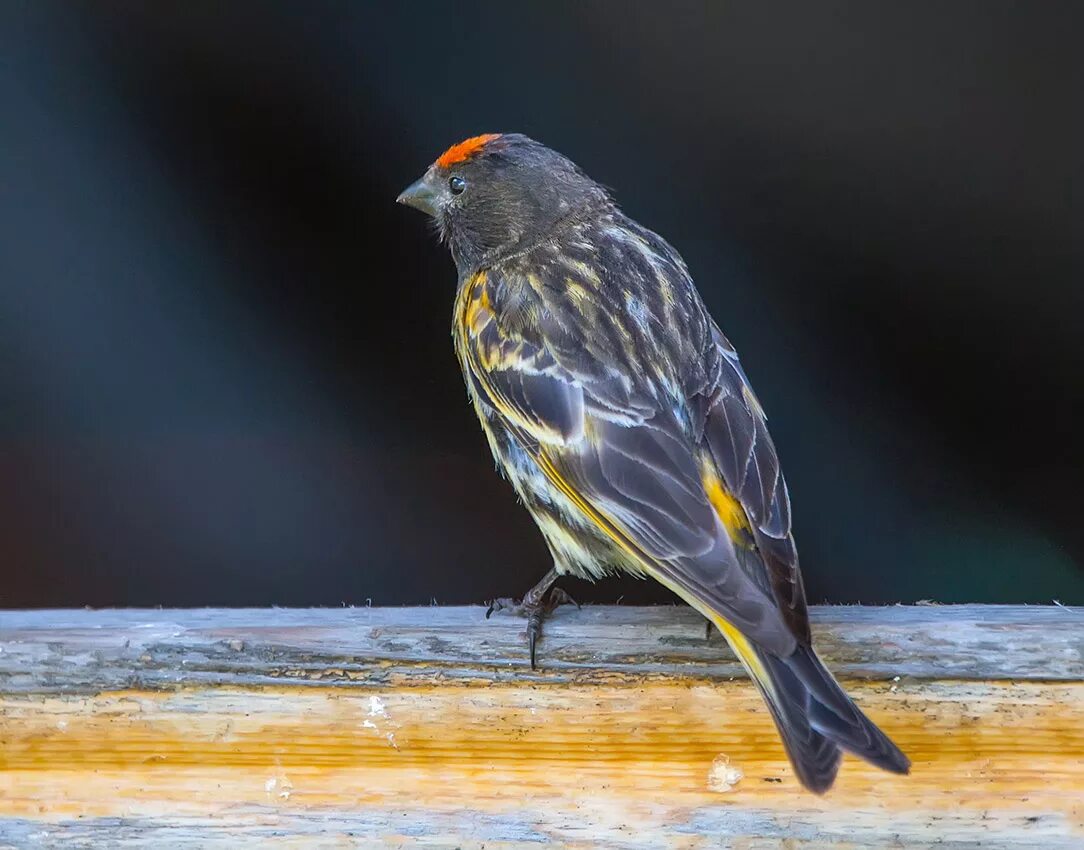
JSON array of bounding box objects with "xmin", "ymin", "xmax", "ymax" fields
[{"xmin": 398, "ymin": 133, "xmax": 609, "ymax": 270}]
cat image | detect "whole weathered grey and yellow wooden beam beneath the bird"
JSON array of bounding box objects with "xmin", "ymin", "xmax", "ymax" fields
[{"xmin": 0, "ymin": 606, "xmax": 1084, "ymax": 850}]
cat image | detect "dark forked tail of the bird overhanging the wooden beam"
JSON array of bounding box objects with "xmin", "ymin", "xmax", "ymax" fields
[{"xmin": 753, "ymin": 646, "xmax": 911, "ymax": 794}]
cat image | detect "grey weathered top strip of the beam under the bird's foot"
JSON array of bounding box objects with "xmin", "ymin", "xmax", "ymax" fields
[{"xmin": 0, "ymin": 605, "xmax": 1084, "ymax": 693}]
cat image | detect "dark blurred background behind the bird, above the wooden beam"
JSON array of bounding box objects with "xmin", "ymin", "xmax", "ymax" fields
[{"xmin": 0, "ymin": 1, "xmax": 1084, "ymax": 607}]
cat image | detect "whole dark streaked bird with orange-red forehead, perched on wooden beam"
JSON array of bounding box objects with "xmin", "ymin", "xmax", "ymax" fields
[{"xmin": 397, "ymin": 132, "xmax": 909, "ymax": 794}]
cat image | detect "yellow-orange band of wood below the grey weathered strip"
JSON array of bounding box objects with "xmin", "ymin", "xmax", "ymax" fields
[{"xmin": 0, "ymin": 679, "xmax": 1084, "ymax": 847}]
